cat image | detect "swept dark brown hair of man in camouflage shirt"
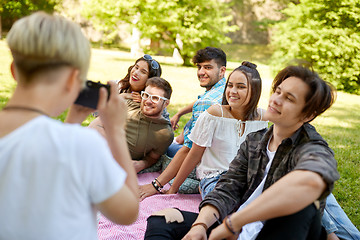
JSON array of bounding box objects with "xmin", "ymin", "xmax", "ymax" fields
[{"xmin": 271, "ymin": 66, "xmax": 336, "ymax": 122}]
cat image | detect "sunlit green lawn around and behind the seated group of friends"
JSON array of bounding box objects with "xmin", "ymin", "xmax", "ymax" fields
[{"xmin": 0, "ymin": 41, "xmax": 360, "ymax": 228}]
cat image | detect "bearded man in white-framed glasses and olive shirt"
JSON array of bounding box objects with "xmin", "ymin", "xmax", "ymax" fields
[{"xmin": 89, "ymin": 77, "xmax": 174, "ymax": 172}]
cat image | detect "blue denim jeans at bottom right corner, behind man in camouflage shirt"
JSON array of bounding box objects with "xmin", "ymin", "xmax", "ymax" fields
[{"xmin": 321, "ymin": 193, "xmax": 360, "ymax": 240}]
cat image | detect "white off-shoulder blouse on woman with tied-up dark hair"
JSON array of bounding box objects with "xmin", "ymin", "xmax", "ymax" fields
[{"xmin": 189, "ymin": 108, "xmax": 268, "ymax": 179}]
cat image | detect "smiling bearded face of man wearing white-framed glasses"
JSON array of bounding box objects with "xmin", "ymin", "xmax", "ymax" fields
[{"xmin": 140, "ymin": 86, "xmax": 169, "ymax": 118}]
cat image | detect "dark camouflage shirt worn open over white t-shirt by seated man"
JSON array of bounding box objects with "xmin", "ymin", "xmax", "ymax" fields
[{"xmin": 199, "ymin": 123, "xmax": 339, "ymax": 218}]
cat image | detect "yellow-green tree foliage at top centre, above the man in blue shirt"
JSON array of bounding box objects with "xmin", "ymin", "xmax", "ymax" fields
[{"xmin": 84, "ymin": 0, "xmax": 237, "ymax": 65}]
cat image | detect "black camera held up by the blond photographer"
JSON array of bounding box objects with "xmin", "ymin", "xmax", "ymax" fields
[{"xmin": 75, "ymin": 80, "xmax": 110, "ymax": 109}]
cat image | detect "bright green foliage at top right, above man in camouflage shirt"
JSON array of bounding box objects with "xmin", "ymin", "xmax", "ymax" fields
[{"xmin": 272, "ymin": 0, "xmax": 360, "ymax": 94}]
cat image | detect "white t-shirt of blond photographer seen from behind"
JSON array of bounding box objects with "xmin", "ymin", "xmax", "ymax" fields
[{"xmin": 0, "ymin": 116, "xmax": 126, "ymax": 240}]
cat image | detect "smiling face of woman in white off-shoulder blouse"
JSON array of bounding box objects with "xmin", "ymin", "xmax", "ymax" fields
[{"xmin": 225, "ymin": 71, "xmax": 251, "ymax": 108}]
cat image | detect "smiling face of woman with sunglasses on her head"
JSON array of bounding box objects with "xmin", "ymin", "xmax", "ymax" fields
[{"xmin": 129, "ymin": 60, "xmax": 149, "ymax": 92}]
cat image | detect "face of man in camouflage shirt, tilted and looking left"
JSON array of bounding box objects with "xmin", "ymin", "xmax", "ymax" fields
[{"xmin": 264, "ymin": 77, "xmax": 310, "ymax": 131}]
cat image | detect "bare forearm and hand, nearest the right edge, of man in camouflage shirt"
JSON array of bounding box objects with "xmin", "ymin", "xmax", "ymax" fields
[{"xmin": 210, "ymin": 170, "xmax": 327, "ymax": 239}]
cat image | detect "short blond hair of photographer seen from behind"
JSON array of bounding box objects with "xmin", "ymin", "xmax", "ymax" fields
[{"xmin": 6, "ymin": 12, "xmax": 90, "ymax": 83}]
